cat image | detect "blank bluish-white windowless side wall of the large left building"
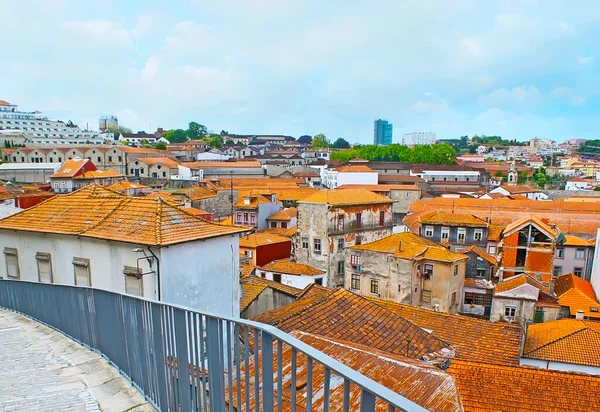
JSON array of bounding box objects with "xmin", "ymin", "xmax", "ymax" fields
[{"xmin": 160, "ymin": 234, "xmax": 240, "ymax": 317}]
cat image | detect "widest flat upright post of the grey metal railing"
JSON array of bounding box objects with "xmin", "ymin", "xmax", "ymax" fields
[{"xmin": 206, "ymin": 316, "xmax": 225, "ymax": 412}]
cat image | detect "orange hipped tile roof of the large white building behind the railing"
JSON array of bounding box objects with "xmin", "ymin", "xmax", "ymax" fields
[{"xmin": 0, "ymin": 185, "xmax": 245, "ymax": 246}]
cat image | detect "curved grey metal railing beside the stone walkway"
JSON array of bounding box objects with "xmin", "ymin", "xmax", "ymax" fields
[{"xmin": 0, "ymin": 280, "xmax": 426, "ymax": 412}]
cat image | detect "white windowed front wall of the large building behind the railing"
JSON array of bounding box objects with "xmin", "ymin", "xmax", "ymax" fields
[{"xmin": 0, "ymin": 230, "xmax": 157, "ymax": 299}]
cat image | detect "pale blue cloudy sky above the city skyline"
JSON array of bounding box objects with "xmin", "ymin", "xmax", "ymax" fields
[{"xmin": 0, "ymin": 0, "xmax": 600, "ymax": 143}]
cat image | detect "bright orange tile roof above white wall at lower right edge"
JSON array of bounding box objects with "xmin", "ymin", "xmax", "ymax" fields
[{"xmin": 523, "ymin": 319, "xmax": 600, "ymax": 367}]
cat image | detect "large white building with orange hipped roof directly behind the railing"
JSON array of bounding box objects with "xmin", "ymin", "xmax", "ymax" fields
[{"xmin": 0, "ymin": 185, "xmax": 244, "ymax": 317}]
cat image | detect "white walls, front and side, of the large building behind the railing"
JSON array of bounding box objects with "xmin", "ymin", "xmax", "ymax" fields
[{"xmin": 0, "ymin": 230, "xmax": 240, "ymax": 317}]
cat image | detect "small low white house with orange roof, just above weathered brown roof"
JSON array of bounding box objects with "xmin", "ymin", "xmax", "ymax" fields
[{"xmin": 255, "ymin": 259, "xmax": 327, "ymax": 289}]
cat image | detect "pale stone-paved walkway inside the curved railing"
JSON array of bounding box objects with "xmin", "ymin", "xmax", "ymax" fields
[{"xmin": 0, "ymin": 309, "xmax": 155, "ymax": 412}]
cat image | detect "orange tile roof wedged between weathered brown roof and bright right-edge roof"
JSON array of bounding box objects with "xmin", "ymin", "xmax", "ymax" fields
[{"xmin": 369, "ymin": 298, "xmax": 522, "ymax": 365}]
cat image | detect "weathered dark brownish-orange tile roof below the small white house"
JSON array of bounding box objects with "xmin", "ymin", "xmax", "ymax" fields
[{"xmin": 253, "ymin": 288, "xmax": 450, "ymax": 359}]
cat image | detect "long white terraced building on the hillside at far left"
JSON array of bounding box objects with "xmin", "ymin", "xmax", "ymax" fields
[{"xmin": 0, "ymin": 100, "xmax": 100, "ymax": 144}]
